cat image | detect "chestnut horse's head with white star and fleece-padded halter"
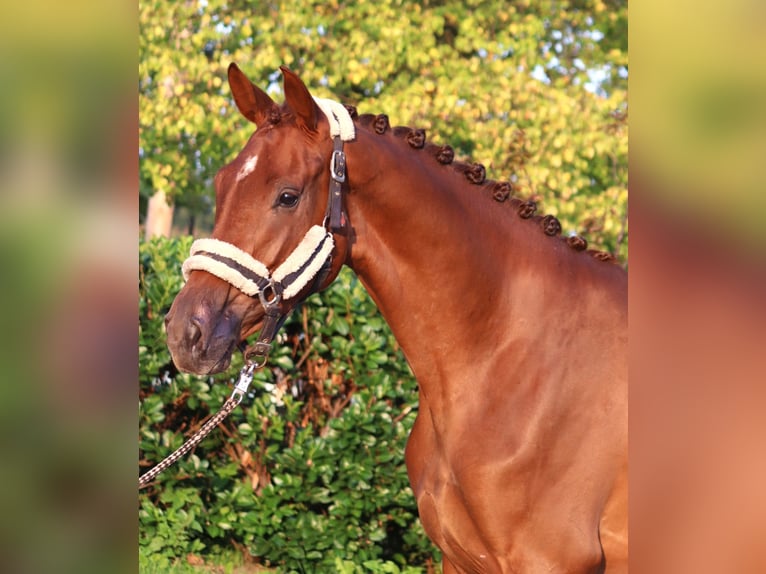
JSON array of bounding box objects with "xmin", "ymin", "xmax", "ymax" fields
[{"xmin": 165, "ymin": 64, "xmax": 350, "ymax": 374}]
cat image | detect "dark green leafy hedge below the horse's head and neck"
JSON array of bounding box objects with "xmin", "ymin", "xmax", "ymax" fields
[{"xmin": 139, "ymin": 237, "xmax": 438, "ymax": 573}]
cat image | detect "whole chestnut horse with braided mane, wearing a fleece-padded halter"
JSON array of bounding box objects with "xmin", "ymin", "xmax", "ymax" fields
[{"xmin": 166, "ymin": 64, "xmax": 628, "ymax": 573}]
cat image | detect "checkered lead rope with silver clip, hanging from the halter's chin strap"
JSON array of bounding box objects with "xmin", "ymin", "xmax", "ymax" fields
[{"xmin": 138, "ymin": 304, "xmax": 281, "ymax": 488}]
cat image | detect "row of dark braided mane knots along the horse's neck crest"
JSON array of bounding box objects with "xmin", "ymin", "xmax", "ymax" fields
[{"xmin": 346, "ymin": 105, "xmax": 618, "ymax": 263}]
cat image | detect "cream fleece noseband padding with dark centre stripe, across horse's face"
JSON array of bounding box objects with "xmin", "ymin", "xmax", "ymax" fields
[{"xmin": 181, "ymin": 225, "xmax": 335, "ymax": 299}]
